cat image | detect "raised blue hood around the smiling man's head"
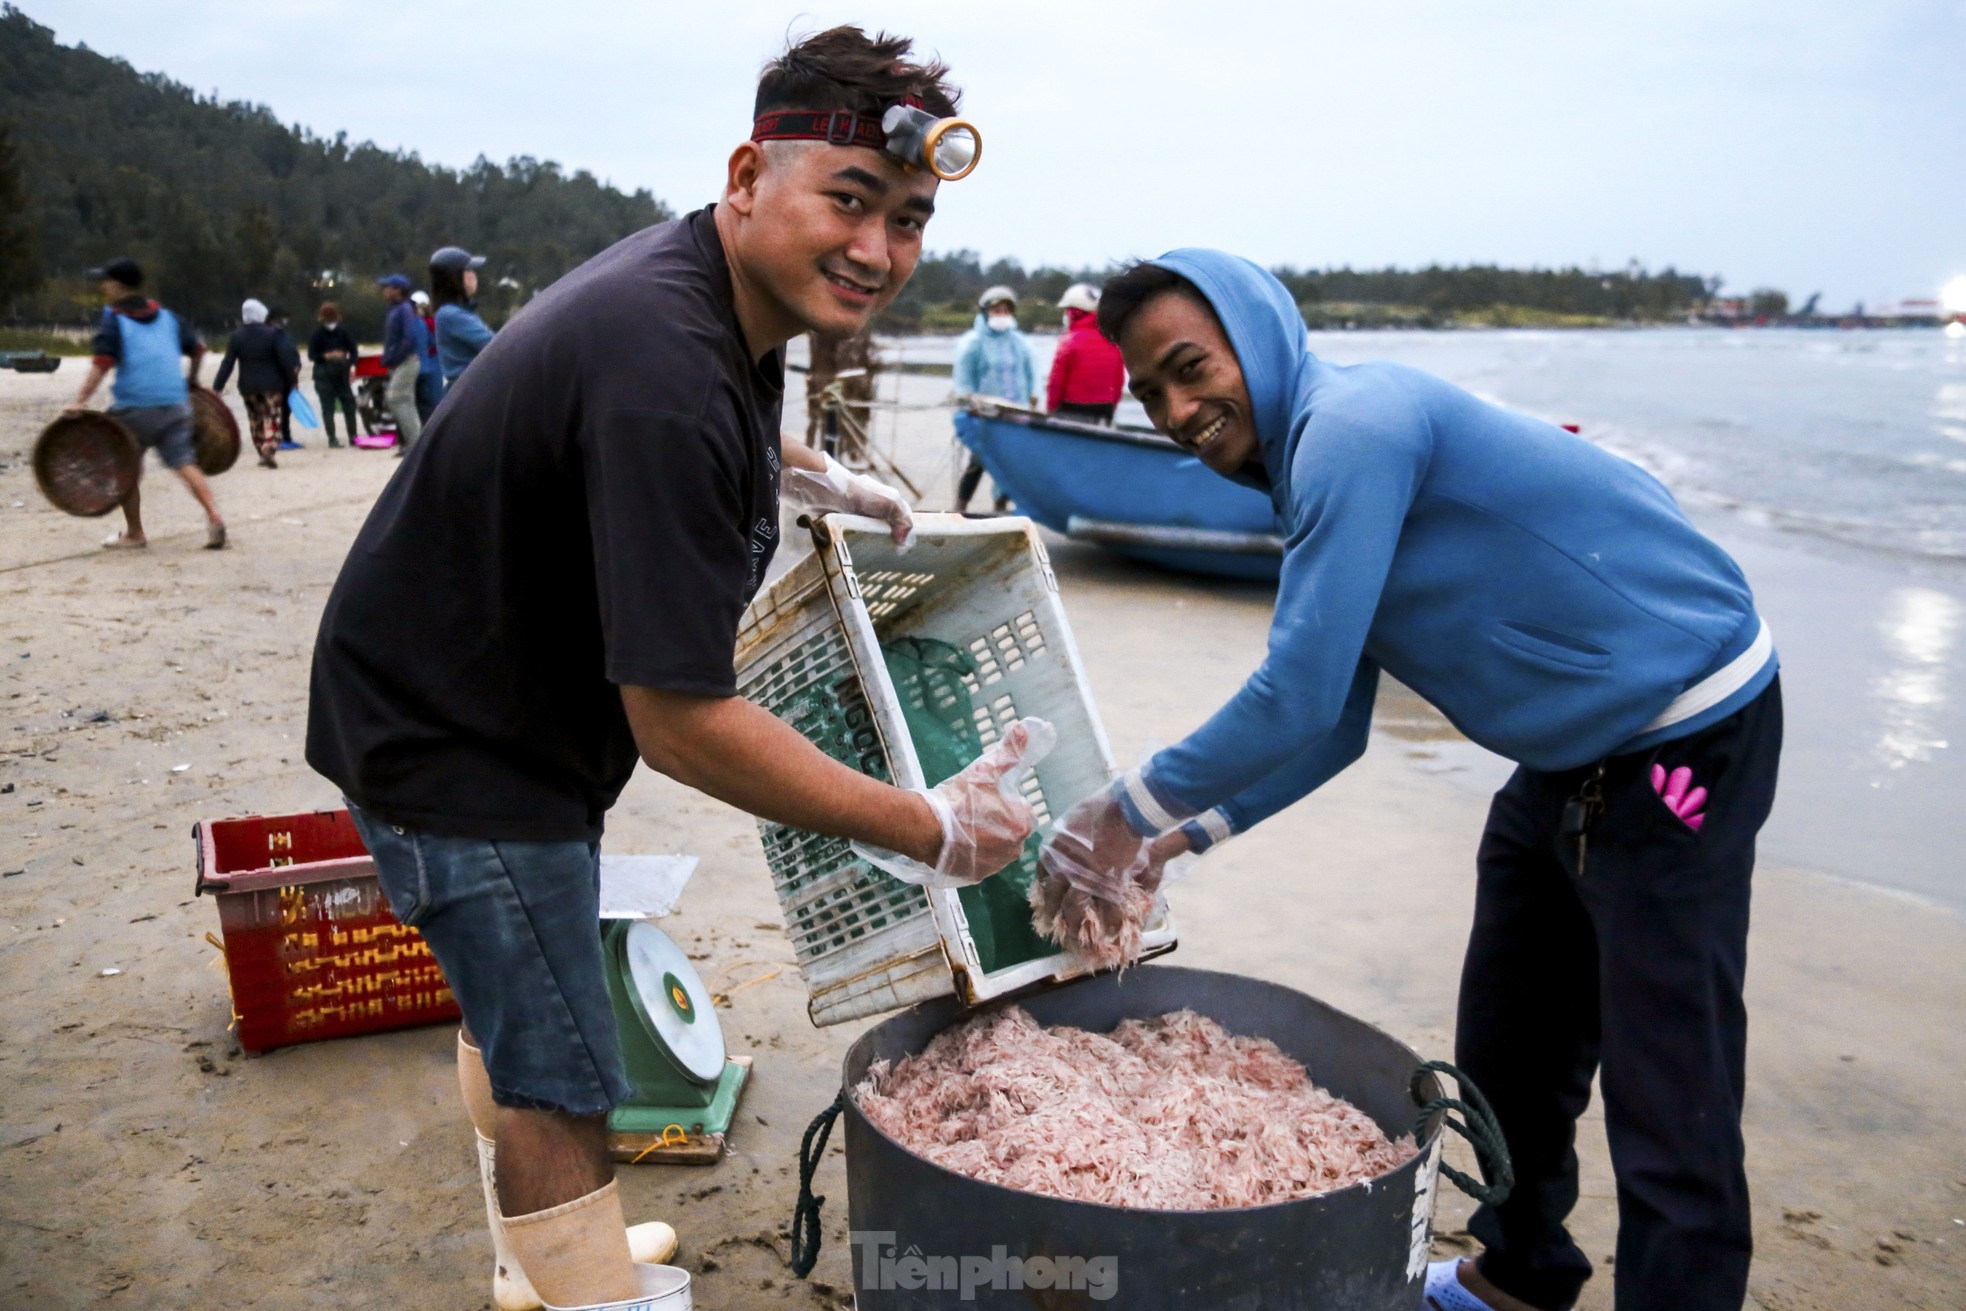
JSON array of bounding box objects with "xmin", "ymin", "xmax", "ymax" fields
[{"xmin": 1152, "ymin": 246, "xmax": 1315, "ymax": 507}]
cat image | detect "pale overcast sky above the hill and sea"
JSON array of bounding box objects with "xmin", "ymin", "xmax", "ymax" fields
[{"xmin": 22, "ymin": 0, "xmax": 1966, "ymax": 309}]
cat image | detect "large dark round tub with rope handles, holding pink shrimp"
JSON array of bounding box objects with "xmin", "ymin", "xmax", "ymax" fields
[{"xmin": 843, "ymin": 965, "xmax": 1441, "ymax": 1311}]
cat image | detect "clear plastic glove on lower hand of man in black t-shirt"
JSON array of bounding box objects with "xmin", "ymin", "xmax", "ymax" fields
[{"xmin": 853, "ymin": 719, "xmax": 1058, "ymax": 888}]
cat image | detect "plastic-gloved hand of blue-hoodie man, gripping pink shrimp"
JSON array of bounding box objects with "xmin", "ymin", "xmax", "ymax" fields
[{"xmin": 1030, "ymin": 788, "xmax": 1187, "ymax": 969}]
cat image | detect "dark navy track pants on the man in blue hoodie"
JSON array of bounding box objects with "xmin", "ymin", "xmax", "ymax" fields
[{"xmin": 1455, "ymin": 680, "xmax": 1781, "ymax": 1311}]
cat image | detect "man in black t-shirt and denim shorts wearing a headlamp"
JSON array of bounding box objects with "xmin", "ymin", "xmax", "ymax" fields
[{"xmin": 307, "ymin": 28, "xmax": 1032, "ymax": 1307}]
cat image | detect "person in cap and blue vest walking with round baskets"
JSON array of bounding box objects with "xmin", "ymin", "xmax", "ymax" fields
[{"xmin": 65, "ymin": 259, "xmax": 226, "ymax": 550}]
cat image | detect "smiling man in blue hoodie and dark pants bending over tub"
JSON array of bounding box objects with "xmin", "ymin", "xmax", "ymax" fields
[{"xmin": 1040, "ymin": 250, "xmax": 1781, "ymax": 1311}]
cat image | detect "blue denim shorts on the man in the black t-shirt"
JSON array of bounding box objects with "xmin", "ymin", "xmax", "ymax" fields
[{"xmin": 348, "ymin": 804, "xmax": 629, "ymax": 1114}]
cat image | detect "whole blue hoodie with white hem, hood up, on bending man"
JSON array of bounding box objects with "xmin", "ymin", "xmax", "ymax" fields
[{"xmin": 1121, "ymin": 250, "xmax": 1777, "ymax": 851}]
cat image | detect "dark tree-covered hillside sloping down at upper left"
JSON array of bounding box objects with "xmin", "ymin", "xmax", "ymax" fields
[{"xmin": 0, "ymin": 4, "xmax": 670, "ymax": 338}]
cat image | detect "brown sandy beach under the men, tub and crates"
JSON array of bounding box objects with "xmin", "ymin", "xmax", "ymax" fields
[{"xmin": 0, "ymin": 360, "xmax": 1966, "ymax": 1311}]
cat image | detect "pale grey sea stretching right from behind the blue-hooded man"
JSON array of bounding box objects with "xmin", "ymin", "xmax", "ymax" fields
[{"xmin": 1311, "ymin": 328, "xmax": 1966, "ymax": 562}]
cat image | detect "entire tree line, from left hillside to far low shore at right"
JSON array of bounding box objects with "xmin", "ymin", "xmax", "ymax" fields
[{"xmin": 0, "ymin": 4, "xmax": 1737, "ymax": 340}]
